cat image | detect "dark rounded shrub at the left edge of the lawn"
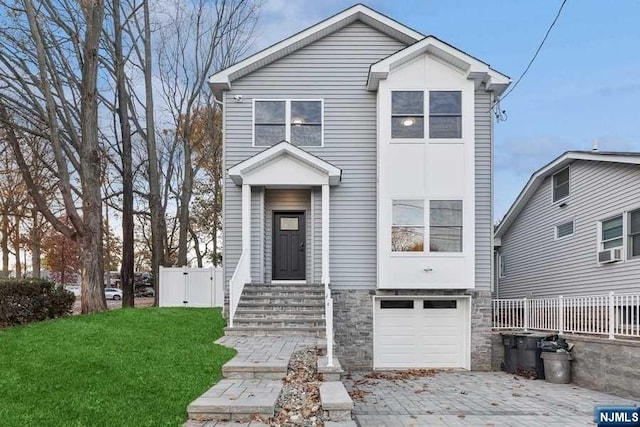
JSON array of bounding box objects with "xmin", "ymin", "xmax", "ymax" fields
[{"xmin": 0, "ymin": 279, "xmax": 75, "ymax": 327}]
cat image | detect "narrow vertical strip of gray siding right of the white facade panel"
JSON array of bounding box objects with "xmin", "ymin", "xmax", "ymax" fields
[{"xmin": 475, "ymin": 89, "xmax": 493, "ymax": 290}]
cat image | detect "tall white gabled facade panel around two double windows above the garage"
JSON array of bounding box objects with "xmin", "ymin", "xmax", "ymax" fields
[{"xmin": 378, "ymin": 54, "xmax": 476, "ymax": 289}]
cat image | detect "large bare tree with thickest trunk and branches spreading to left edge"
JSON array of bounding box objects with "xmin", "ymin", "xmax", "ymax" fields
[{"xmin": 0, "ymin": 0, "xmax": 106, "ymax": 313}]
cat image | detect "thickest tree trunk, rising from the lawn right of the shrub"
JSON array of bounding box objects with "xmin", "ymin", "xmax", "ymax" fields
[{"xmin": 79, "ymin": 0, "xmax": 107, "ymax": 314}]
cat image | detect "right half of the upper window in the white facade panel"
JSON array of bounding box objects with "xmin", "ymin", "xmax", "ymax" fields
[{"xmin": 429, "ymin": 91, "xmax": 462, "ymax": 138}]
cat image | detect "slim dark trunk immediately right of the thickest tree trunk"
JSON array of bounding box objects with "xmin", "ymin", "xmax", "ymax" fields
[{"xmin": 113, "ymin": 0, "xmax": 135, "ymax": 307}]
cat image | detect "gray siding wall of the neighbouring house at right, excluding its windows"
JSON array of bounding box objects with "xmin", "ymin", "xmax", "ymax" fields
[{"xmin": 499, "ymin": 160, "xmax": 640, "ymax": 298}]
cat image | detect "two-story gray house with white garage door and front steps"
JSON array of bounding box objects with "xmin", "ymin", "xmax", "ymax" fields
[{"xmin": 210, "ymin": 5, "xmax": 510, "ymax": 369}]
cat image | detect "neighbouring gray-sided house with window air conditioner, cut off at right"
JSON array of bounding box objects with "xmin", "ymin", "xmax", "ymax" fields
[{"xmin": 494, "ymin": 151, "xmax": 640, "ymax": 298}]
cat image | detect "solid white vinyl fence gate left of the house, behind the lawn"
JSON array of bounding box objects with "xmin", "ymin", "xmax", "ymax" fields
[{"xmin": 158, "ymin": 267, "xmax": 224, "ymax": 307}]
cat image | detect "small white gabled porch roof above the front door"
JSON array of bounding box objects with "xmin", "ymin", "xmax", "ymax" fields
[{"xmin": 229, "ymin": 141, "xmax": 342, "ymax": 186}]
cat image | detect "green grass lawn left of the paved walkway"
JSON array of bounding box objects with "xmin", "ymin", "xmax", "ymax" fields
[{"xmin": 0, "ymin": 308, "xmax": 235, "ymax": 427}]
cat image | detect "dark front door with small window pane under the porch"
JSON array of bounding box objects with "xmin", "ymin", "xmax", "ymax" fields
[{"xmin": 273, "ymin": 212, "xmax": 306, "ymax": 280}]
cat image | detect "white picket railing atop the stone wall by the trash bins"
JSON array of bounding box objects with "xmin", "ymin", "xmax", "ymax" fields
[{"xmin": 492, "ymin": 292, "xmax": 640, "ymax": 339}]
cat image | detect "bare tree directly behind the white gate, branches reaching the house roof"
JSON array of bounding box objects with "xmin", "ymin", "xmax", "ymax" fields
[{"xmin": 158, "ymin": 0, "xmax": 261, "ymax": 265}]
